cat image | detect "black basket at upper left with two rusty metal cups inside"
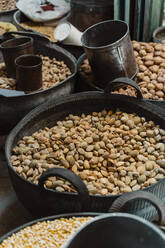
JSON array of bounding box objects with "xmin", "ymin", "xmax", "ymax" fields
[{"xmin": 0, "ymin": 35, "xmax": 77, "ymax": 134}]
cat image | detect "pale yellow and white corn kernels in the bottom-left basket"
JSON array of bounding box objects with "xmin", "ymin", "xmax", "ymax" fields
[{"xmin": 0, "ymin": 216, "xmax": 92, "ymax": 248}]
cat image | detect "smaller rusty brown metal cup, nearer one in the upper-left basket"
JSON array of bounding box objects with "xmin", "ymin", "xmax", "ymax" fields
[{"xmin": 15, "ymin": 54, "xmax": 42, "ymax": 92}]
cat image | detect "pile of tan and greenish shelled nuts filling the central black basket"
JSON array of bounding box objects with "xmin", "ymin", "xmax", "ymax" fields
[{"xmin": 11, "ymin": 110, "xmax": 165, "ymax": 195}]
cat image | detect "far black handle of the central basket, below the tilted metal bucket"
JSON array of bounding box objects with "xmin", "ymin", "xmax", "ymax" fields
[{"xmin": 104, "ymin": 77, "xmax": 143, "ymax": 99}]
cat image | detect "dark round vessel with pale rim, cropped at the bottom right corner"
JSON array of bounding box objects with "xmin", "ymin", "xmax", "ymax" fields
[{"xmin": 64, "ymin": 213, "xmax": 165, "ymax": 248}]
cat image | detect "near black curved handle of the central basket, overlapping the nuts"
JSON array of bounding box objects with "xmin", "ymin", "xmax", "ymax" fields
[{"xmin": 38, "ymin": 168, "xmax": 90, "ymax": 209}]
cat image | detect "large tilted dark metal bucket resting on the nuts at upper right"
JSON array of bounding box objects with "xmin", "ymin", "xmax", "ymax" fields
[{"xmin": 81, "ymin": 20, "xmax": 138, "ymax": 89}]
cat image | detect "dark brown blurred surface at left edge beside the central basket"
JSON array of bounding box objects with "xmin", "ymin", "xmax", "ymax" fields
[{"xmin": 0, "ymin": 136, "xmax": 33, "ymax": 237}]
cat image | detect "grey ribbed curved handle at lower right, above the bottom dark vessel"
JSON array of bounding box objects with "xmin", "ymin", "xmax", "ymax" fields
[{"xmin": 108, "ymin": 191, "xmax": 165, "ymax": 225}]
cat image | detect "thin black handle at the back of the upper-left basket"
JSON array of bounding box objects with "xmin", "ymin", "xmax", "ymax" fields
[{"xmin": 3, "ymin": 31, "xmax": 50, "ymax": 43}]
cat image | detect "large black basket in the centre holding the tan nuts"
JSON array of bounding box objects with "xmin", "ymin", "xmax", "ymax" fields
[{"xmin": 5, "ymin": 80, "xmax": 165, "ymax": 219}]
